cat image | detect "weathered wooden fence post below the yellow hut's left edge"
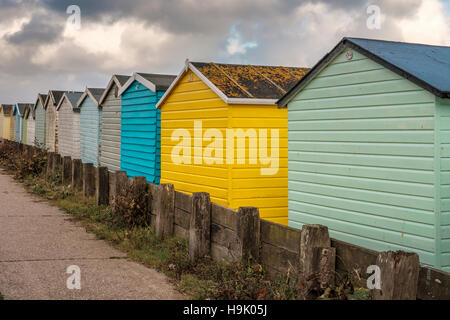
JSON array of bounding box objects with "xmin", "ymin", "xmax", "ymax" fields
[{"xmin": 153, "ymin": 184, "xmax": 175, "ymax": 239}]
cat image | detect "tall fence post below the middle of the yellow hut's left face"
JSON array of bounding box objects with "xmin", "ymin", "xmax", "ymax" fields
[{"xmin": 189, "ymin": 192, "xmax": 211, "ymax": 262}]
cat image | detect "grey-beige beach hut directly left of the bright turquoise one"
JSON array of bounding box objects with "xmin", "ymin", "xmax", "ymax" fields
[{"xmin": 99, "ymin": 75, "xmax": 130, "ymax": 171}]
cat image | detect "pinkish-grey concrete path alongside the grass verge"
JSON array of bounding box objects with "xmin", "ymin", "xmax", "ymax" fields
[{"xmin": 0, "ymin": 169, "xmax": 184, "ymax": 300}]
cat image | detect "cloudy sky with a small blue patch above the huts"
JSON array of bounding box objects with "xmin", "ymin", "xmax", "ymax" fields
[{"xmin": 0, "ymin": 0, "xmax": 450, "ymax": 103}]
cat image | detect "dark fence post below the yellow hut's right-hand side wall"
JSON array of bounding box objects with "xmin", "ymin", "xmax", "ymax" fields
[{"xmin": 237, "ymin": 207, "xmax": 261, "ymax": 261}]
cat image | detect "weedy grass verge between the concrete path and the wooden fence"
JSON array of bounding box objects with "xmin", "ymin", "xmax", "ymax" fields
[{"xmin": 23, "ymin": 172, "xmax": 370, "ymax": 300}]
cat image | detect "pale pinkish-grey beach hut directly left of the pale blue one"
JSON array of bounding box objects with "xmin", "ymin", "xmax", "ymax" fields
[{"xmin": 56, "ymin": 91, "xmax": 83, "ymax": 159}]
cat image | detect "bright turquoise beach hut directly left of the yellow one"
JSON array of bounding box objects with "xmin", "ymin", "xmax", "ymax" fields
[{"xmin": 119, "ymin": 73, "xmax": 176, "ymax": 184}]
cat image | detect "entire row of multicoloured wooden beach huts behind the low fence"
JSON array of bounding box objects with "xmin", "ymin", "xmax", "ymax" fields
[{"xmin": 0, "ymin": 38, "xmax": 450, "ymax": 271}]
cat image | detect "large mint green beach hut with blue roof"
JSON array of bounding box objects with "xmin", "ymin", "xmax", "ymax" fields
[{"xmin": 279, "ymin": 38, "xmax": 450, "ymax": 271}]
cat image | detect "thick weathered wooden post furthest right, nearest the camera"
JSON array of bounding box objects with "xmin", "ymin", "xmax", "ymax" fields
[{"xmin": 372, "ymin": 251, "xmax": 420, "ymax": 300}]
